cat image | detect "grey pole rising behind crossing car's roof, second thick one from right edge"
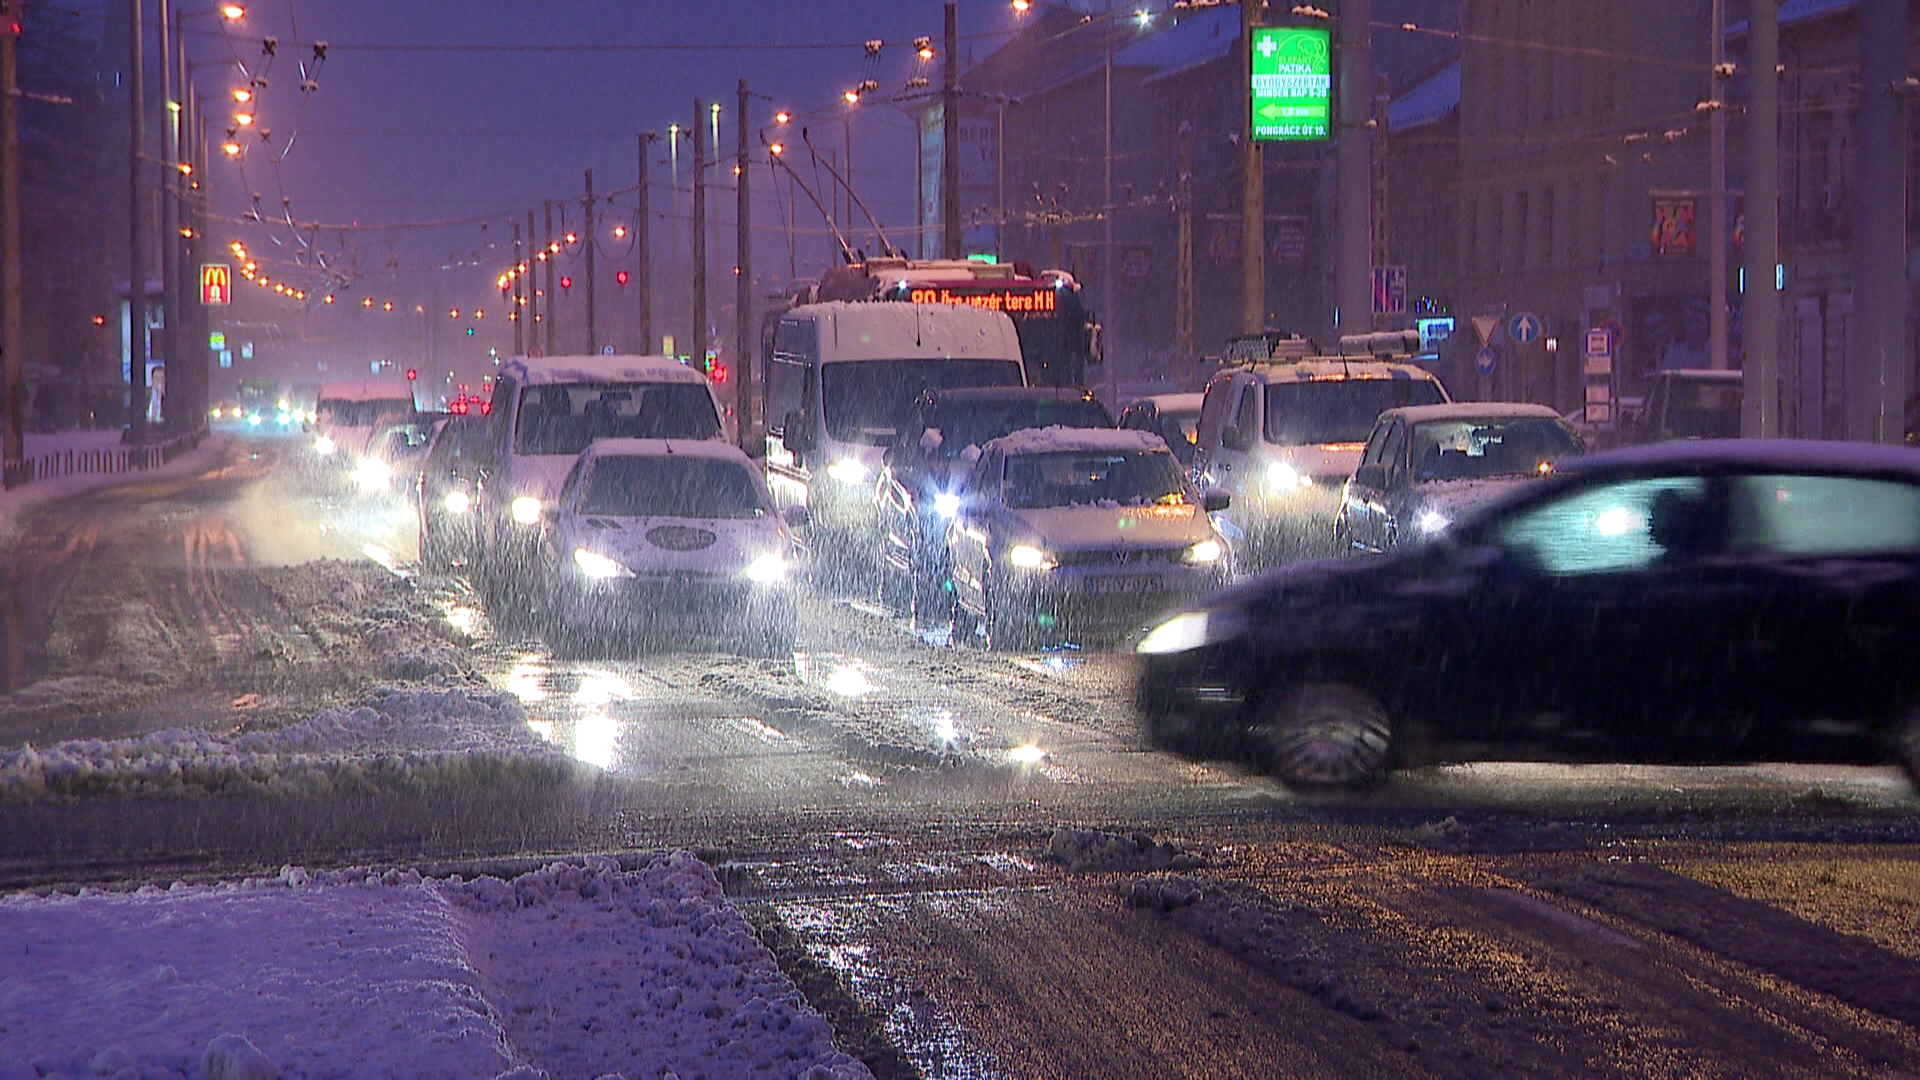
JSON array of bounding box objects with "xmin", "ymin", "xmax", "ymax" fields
[{"xmin": 1740, "ymin": 0, "xmax": 1774, "ymax": 438}]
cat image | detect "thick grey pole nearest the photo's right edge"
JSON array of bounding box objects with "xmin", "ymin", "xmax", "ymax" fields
[{"xmin": 1843, "ymin": 0, "xmax": 1912, "ymax": 444}]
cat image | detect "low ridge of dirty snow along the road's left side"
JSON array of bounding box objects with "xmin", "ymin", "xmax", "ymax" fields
[{"xmin": 0, "ymin": 688, "xmax": 589, "ymax": 801}]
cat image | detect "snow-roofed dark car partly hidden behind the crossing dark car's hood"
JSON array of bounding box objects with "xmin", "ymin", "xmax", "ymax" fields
[{"xmin": 1332, "ymin": 402, "xmax": 1586, "ymax": 553}]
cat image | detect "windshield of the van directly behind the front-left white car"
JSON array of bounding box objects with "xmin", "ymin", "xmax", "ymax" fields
[{"xmin": 513, "ymin": 382, "xmax": 720, "ymax": 455}]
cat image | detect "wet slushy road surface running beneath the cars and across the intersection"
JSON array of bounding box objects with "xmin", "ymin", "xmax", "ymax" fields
[{"xmin": 0, "ymin": 432, "xmax": 1920, "ymax": 1078}]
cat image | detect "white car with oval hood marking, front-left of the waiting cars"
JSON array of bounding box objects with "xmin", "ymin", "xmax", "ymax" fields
[{"xmin": 541, "ymin": 430, "xmax": 804, "ymax": 657}]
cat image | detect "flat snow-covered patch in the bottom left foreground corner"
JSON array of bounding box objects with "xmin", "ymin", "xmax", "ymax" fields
[{"xmin": 0, "ymin": 853, "xmax": 872, "ymax": 1080}]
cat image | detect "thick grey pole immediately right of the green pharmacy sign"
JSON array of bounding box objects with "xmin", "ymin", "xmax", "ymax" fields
[{"xmin": 1334, "ymin": 0, "xmax": 1373, "ymax": 334}]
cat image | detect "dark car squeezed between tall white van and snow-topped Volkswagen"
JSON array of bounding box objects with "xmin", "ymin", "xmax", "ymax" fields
[{"xmin": 876, "ymin": 386, "xmax": 1114, "ymax": 626}]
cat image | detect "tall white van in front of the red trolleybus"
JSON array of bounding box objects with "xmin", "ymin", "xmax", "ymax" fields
[{"xmin": 766, "ymin": 300, "xmax": 1027, "ymax": 571}]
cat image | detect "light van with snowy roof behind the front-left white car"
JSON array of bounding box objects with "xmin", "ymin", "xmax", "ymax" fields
[{"xmin": 474, "ymin": 356, "xmax": 726, "ymax": 584}]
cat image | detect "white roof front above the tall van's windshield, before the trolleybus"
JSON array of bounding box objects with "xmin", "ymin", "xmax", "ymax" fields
[{"xmin": 781, "ymin": 300, "xmax": 1020, "ymax": 361}]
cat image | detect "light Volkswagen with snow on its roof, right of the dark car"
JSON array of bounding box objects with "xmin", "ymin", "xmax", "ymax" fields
[{"xmin": 947, "ymin": 427, "xmax": 1227, "ymax": 648}]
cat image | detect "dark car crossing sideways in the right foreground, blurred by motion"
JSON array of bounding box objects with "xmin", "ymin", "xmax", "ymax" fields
[{"xmin": 1137, "ymin": 440, "xmax": 1920, "ymax": 786}]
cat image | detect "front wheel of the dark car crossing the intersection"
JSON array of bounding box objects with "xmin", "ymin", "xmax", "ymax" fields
[{"xmin": 1252, "ymin": 682, "xmax": 1394, "ymax": 790}]
